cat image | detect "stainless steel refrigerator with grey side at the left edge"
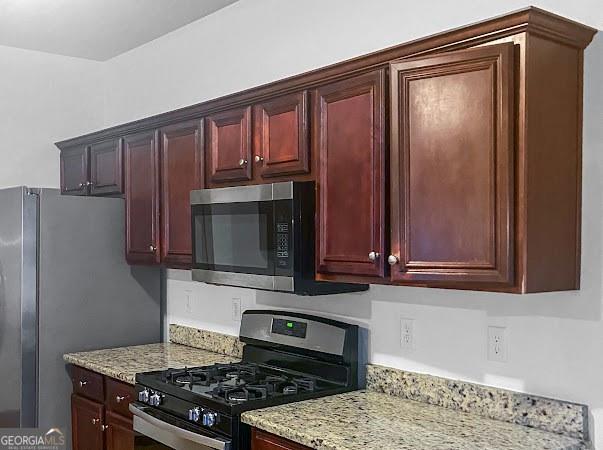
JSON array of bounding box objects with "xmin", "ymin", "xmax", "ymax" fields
[{"xmin": 0, "ymin": 187, "xmax": 161, "ymax": 435}]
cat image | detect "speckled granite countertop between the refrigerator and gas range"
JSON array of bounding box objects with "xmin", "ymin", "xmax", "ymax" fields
[{"xmin": 63, "ymin": 343, "xmax": 239, "ymax": 384}]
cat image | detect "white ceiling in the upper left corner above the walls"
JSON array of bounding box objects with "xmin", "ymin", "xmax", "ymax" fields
[{"xmin": 0, "ymin": 0, "xmax": 236, "ymax": 61}]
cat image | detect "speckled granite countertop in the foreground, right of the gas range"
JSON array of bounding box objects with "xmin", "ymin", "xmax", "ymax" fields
[{"xmin": 242, "ymin": 391, "xmax": 587, "ymax": 450}]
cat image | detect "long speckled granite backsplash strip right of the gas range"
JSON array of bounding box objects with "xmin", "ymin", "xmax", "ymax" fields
[{"xmin": 367, "ymin": 365, "xmax": 589, "ymax": 440}]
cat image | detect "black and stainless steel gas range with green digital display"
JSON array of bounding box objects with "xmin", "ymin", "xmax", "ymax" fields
[{"xmin": 130, "ymin": 310, "xmax": 366, "ymax": 450}]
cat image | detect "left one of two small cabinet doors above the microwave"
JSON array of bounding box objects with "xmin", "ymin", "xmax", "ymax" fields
[{"xmin": 207, "ymin": 106, "xmax": 251, "ymax": 183}]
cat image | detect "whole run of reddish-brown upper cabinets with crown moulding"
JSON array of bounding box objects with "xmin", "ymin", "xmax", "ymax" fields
[{"xmin": 57, "ymin": 7, "xmax": 597, "ymax": 293}]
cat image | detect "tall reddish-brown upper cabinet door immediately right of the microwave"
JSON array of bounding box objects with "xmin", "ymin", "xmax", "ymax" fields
[{"xmin": 312, "ymin": 70, "xmax": 385, "ymax": 279}]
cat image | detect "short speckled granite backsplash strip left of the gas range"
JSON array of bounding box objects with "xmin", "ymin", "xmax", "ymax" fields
[{"xmin": 170, "ymin": 324, "xmax": 244, "ymax": 358}]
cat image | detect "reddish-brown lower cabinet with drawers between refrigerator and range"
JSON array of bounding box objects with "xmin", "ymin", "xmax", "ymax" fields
[{"xmin": 70, "ymin": 366, "xmax": 134, "ymax": 450}]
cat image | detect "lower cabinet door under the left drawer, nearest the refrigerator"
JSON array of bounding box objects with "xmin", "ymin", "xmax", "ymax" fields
[{"xmin": 71, "ymin": 394, "xmax": 104, "ymax": 450}]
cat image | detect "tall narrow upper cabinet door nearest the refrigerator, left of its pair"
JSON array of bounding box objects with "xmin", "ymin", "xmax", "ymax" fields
[{"xmin": 124, "ymin": 132, "xmax": 160, "ymax": 264}]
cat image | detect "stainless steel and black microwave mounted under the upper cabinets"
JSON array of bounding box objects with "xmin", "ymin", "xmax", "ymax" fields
[{"xmin": 190, "ymin": 181, "xmax": 368, "ymax": 295}]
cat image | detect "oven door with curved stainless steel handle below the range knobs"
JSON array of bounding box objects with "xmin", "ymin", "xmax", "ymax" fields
[{"xmin": 130, "ymin": 403, "xmax": 232, "ymax": 450}]
